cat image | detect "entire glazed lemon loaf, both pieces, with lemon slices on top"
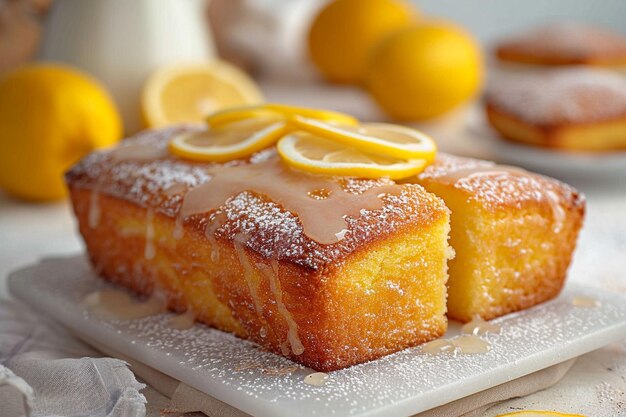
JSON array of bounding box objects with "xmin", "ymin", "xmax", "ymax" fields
[{"xmin": 66, "ymin": 103, "xmax": 584, "ymax": 371}]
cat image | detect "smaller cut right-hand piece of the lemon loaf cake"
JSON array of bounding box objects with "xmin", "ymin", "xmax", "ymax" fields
[{"xmin": 417, "ymin": 154, "xmax": 585, "ymax": 321}]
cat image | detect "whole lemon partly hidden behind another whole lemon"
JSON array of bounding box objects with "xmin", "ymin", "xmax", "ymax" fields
[{"xmin": 309, "ymin": 0, "xmax": 418, "ymax": 83}]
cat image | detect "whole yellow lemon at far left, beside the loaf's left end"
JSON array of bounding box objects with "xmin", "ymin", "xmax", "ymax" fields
[{"xmin": 0, "ymin": 64, "xmax": 122, "ymax": 201}]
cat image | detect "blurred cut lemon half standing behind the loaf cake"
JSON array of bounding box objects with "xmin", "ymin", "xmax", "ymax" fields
[{"xmin": 141, "ymin": 60, "xmax": 263, "ymax": 127}]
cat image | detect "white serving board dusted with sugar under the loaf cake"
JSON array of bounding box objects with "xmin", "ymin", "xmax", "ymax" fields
[{"xmin": 9, "ymin": 256, "xmax": 626, "ymax": 417}]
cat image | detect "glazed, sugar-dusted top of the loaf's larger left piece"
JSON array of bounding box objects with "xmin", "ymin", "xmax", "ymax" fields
[{"xmin": 66, "ymin": 128, "xmax": 447, "ymax": 269}]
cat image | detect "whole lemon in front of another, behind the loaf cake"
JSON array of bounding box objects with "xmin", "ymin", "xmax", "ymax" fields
[{"xmin": 365, "ymin": 21, "xmax": 483, "ymax": 120}]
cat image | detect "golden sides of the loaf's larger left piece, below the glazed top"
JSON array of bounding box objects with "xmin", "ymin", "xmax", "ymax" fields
[{"xmin": 71, "ymin": 189, "xmax": 449, "ymax": 371}]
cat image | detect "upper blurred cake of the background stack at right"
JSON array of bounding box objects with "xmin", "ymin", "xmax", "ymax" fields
[{"xmin": 495, "ymin": 23, "xmax": 626, "ymax": 66}]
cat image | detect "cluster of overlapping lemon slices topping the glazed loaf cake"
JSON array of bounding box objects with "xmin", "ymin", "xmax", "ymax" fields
[{"xmin": 169, "ymin": 104, "xmax": 437, "ymax": 179}]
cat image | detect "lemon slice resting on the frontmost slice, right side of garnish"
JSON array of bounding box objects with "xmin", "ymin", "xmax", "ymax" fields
[{"xmin": 292, "ymin": 116, "xmax": 437, "ymax": 162}]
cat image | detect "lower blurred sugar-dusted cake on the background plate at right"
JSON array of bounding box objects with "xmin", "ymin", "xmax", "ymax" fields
[{"xmin": 485, "ymin": 68, "xmax": 626, "ymax": 152}]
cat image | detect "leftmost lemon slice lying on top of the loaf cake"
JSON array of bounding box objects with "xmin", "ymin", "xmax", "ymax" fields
[{"xmin": 169, "ymin": 119, "xmax": 289, "ymax": 162}]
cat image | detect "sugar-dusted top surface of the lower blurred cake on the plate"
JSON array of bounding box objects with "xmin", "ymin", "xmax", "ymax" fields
[{"xmin": 487, "ymin": 68, "xmax": 626, "ymax": 127}]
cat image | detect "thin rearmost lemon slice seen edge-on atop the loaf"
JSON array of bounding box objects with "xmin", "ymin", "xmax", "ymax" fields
[{"xmin": 206, "ymin": 103, "xmax": 359, "ymax": 127}]
